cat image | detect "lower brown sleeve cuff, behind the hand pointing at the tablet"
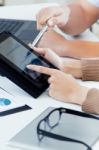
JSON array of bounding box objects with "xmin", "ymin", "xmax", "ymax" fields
[{"xmin": 82, "ymin": 88, "xmax": 99, "ymax": 115}]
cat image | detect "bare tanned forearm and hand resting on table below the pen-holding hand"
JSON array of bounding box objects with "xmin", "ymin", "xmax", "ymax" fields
[{"xmin": 38, "ymin": 30, "xmax": 99, "ymax": 59}]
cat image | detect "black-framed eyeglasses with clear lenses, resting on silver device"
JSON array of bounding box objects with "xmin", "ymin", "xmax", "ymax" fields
[{"xmin": 37, "ymin": 107, "xmax": 99, "ymax": 150}]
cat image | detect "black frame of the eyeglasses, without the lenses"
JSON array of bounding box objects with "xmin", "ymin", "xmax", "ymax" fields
[{"xmin": 37, "ymin": 107, "xmax": 99, "ymax": 150}]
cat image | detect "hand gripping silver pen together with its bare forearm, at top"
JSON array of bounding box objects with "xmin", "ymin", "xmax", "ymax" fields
[{"xmin": 37, "ymin": 0, "xmax": 99, "ymax": 35}]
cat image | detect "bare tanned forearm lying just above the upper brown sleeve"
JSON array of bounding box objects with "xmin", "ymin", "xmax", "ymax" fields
[{"xmin": 62, "ymin": 40, "xmax": 99, "ymax": 59}]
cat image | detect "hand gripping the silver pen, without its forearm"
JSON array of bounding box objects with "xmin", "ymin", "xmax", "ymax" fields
[{"xmin": 36, "ymin": 6, "xmax": 70, "ymax": 29}]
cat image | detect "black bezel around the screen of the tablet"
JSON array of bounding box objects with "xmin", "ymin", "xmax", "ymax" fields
[{"xmin": 0, "ymin": 32, "xmax": 56, "ymax": 98}]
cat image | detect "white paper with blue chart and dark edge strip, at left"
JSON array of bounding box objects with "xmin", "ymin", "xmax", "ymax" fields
[{"xmin": 0, "ymin": 88, "xmax": 31, "ymax": 116}]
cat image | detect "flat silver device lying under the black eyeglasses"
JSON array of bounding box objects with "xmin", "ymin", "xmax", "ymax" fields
[{"xmin": 8, "ymin": 107, "xmax": 99, "ymax": 150}]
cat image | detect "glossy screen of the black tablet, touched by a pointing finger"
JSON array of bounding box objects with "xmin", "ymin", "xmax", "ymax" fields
[{"xmin": 0, "ymin": 36, "xmax": 49, "ymax": 79}]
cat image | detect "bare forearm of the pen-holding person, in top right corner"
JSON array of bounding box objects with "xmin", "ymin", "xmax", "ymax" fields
[{"xmin": 61, "ymin": 0, "xmax": 99, "ymax": 35}]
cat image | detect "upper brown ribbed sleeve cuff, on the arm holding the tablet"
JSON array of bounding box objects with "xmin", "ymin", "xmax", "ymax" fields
[{"xmin": 81, "ymin": 57, "xmax": 99, "ymax": 81}]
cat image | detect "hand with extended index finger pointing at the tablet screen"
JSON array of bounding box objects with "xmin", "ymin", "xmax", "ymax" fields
[{"xmin": 27, "ymin": 65, "xmax": 89, "ymax": 105}]
